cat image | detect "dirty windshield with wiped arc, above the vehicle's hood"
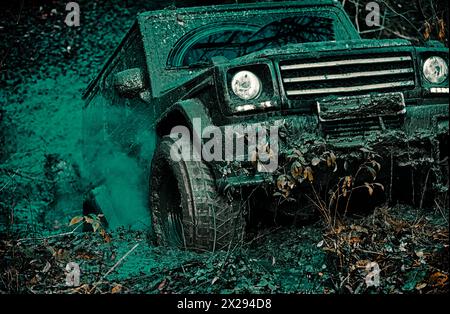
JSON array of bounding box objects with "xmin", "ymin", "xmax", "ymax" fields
[{"xmin": 169, "ymin": 15, "xmax": 335, "ymax": 67}]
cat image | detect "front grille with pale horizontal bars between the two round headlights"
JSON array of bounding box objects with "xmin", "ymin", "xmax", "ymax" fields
[{"xmin": 280, "ymin": 52, "xmax": 415, "ymax": 99}]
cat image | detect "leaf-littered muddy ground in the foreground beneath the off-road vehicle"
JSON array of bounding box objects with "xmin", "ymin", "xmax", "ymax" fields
[{"xmin": 0, "ymin": 206, "xmax": 449, "ymax": 294}]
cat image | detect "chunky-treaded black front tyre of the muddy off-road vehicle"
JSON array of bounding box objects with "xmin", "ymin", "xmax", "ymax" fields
[{"xmin": 150, "ymin": 136, "xmax": 245, "ymax": 251}]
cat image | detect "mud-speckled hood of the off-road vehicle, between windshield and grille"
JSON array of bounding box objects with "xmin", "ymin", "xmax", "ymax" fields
[{"xmin": 232, "ymin": 39, "xmax": 412, "ymax": 63}]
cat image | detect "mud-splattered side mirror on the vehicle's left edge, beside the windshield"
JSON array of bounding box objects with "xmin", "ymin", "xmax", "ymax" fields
[{"xmin": 114, "ymin": 68, "xmax": 145, "ymax": 98}]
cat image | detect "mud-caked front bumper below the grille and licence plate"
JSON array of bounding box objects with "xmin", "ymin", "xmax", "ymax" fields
[{"xmin": 213, "ymin": 102, "xmax": 449, "ymax": 192}]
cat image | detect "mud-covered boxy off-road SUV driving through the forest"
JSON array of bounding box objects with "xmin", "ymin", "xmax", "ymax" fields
[{"xmin": 84, "ymin": 0, "xmax": 449, "ymax": 250}]
